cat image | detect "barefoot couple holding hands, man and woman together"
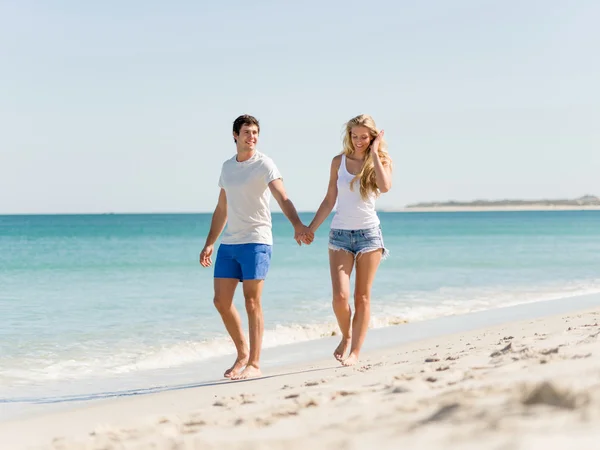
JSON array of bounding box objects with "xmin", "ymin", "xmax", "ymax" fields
[{"xmin": 200, "ymin": 114, "xmax": 392, "ymax": 380}]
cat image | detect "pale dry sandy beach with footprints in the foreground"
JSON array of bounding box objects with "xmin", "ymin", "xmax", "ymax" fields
[{"xmin": 0, "ymin": 299, "xmax": 600, "ymax": 450}]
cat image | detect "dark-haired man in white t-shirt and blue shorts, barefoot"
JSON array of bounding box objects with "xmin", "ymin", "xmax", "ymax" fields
[{"xmin": 200, "ymin": 115, "xmax": 314, "ymax": 380}]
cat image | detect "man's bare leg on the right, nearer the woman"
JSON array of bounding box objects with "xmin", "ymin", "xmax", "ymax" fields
[{"xmin": 231, "ymin": 280, "xmax": 264, "ymax": 380}]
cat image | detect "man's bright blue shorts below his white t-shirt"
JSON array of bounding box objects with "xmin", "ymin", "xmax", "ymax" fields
[{"xmin": 215, "ymin": 244, "xmax": 272, "ymax": 281}]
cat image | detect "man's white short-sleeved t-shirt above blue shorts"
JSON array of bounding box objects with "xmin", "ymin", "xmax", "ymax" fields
[{"xmin": 219, "ymin": 151, "xmax": 282, "ymax": 245}]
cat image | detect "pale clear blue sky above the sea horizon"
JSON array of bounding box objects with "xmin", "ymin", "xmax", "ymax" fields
[{"xmin": 0, "ymin": 0, "xmax": 600, "ymax": 213}]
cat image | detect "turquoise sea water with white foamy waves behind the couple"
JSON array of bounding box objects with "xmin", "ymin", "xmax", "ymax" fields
[{"xmin": 0, "ymin": 211, "xmax": 600, "ymax": 399}]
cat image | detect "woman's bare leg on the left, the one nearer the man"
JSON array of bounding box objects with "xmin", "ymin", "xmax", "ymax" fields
[{"xmin": 329, "ymin": 250, "xmax": 354, "ymax": 361}]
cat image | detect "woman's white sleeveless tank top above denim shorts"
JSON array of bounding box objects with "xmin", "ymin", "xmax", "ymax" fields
[{"xmin": 331, "ymin": 154, "xmax": 379, "ymax": 230}]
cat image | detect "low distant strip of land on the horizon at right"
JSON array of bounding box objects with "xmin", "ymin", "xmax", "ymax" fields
[{"xmin": 404, "ymin": 195, "xmax": 600, "ymax": 211}]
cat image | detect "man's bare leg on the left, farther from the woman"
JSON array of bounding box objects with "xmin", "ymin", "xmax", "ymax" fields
[{"xmin": 214, "ymin": 278, "xmax": 248, "ymax": 378}]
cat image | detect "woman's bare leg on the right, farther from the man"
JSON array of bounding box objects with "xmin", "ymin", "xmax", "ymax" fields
[{"xmin": 342, "ymin": 251, "xmax": 382, "ymax": 366}]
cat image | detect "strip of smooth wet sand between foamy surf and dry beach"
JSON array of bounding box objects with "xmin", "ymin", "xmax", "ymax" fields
[{"xmin": 0, "ymin": 292, "xmax": 600, "ymax": 414}]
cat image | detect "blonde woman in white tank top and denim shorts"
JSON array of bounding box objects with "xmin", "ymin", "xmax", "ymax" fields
[{"xmin": 309, "ymin": 114, "xmax": 392, "ymax": 366}]
